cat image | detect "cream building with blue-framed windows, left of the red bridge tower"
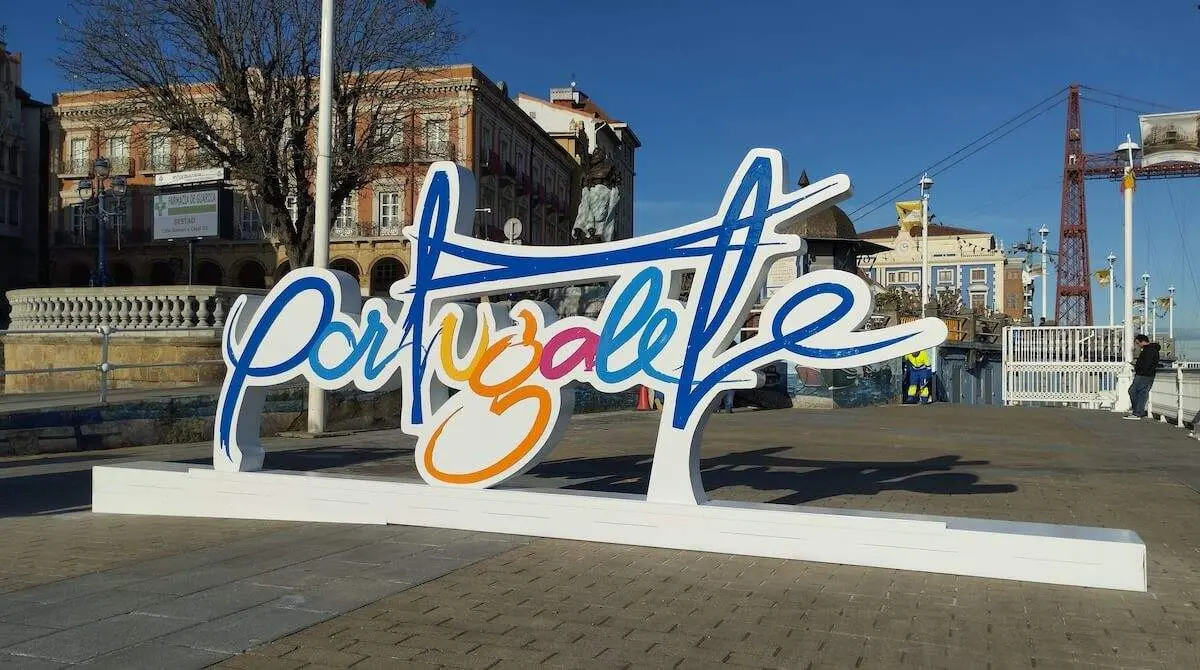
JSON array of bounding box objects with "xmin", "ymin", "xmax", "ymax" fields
[{"xmin": 860, "ymin": 223, "xmax": 1024, "ymax": 313}]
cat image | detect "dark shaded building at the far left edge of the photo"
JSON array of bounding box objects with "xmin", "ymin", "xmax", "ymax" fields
[{"xmin": 0, "ymin": 41, "xmax": 48, "ymax": 325}]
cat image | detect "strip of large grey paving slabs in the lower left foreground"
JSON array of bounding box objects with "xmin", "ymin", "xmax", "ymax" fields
[{"xmin": 0, "ymin": 528, "xmax": 527, "ymax": 669}]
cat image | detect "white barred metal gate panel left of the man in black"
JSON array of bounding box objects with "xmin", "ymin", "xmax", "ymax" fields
[{"xmin": 1003, "ymin": 327, "xmax": 1124, "ymax": 408}]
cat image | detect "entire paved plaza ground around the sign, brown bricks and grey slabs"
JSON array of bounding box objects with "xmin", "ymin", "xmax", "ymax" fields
[{"xmin": 0, "ymin": 406, "xmax": 1200, "ymax": 669}]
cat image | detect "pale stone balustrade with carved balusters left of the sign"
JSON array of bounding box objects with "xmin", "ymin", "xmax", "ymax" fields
[{"xmin": 7, "ymin": 286, "xmax": 266, "ymax": 334}]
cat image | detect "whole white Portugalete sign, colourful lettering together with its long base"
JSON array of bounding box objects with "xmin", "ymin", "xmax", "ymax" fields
[{"xmin": 92, "ymin": 149, "xmax": 1146, "ymax": 591}]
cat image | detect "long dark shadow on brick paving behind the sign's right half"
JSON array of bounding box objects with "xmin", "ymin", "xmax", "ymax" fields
[{"xmin": 529, "ymin": 447, "xmax": 1016, "ymax": 504}]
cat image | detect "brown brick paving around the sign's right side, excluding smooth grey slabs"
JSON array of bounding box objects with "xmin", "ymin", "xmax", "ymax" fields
[{"xmin": 220, "ymin": 406, "xmax": 1200, "ymax": 669}]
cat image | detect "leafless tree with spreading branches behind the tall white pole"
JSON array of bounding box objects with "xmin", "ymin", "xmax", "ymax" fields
[{"xmin": 60, "ymin": 0, "xmax": 461, "ymax": 268}]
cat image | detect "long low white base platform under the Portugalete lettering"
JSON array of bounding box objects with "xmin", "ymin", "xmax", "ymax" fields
[{"xmin": 92, "ymin": 462, "xmax": 1146, "ymax": 591}]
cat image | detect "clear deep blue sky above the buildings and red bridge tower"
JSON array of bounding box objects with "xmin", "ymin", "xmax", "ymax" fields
[{"xmin": 4, "ymin": 0, "xmax": 1200, "ymax": 358}]
